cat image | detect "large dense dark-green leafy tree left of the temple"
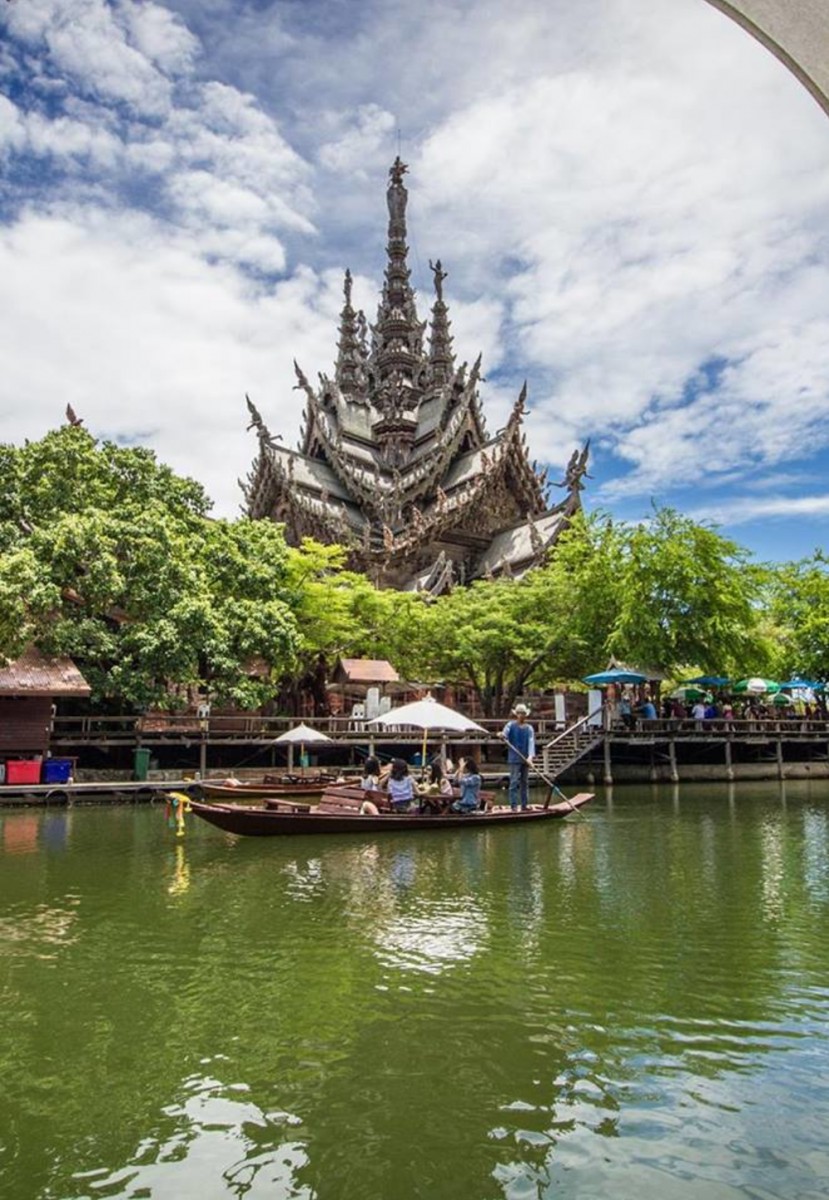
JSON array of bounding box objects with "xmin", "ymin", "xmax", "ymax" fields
[{"xmin": 0, "ymin": 426, "xmax": 299, "ymax": 707}]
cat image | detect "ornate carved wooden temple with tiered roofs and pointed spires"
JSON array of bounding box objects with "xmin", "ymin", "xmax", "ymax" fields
[{"xmin": 242, "ymin": 158, "xmax": 588, "ymax": 595}]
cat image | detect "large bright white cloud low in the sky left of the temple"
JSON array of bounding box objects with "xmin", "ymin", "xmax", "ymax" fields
[{"xmin": 0, "ymin": 210, "xmax": 337, "ymax": 512}]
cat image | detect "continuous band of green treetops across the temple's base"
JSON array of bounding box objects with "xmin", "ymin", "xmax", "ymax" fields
[{"xmin": 0, "ymin": 425, "xmax": 815, "ymax": 715}]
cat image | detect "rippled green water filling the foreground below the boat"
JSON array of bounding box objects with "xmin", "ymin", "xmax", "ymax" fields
[{"xmin": 0, "ymin": 784, "xmax": 829, "ymax": 1200}]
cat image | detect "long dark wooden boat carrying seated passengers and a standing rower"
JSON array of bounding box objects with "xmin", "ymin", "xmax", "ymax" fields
[{"xmin": 191, "ymin": 787, "xmax": 593, "ymax": 838}]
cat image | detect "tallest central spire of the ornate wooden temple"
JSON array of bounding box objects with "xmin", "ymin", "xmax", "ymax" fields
[{"xmin": 372, "ymin": 156, "xmax": 426, "ymax": 379}]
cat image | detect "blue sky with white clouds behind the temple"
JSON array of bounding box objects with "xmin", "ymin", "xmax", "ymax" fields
[{"xmin": 0, "ymin": 0, "xmax": 829, "ymax": 559}]
